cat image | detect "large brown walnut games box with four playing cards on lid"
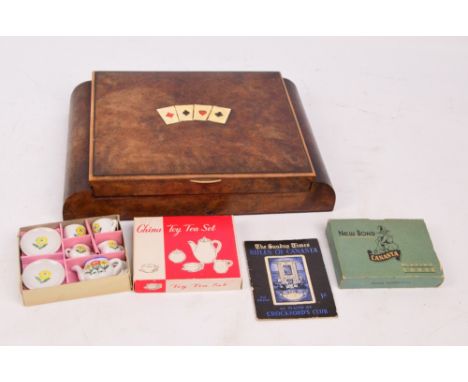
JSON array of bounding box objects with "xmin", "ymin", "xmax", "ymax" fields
[{"xmin": 63, "ymin": 72, "xmax": 335, "ymax": 219}]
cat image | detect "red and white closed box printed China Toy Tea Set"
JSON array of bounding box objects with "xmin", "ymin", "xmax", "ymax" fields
[{"xmin": 133, "ymin": 216, "xmax": 241, "ymax": 293}]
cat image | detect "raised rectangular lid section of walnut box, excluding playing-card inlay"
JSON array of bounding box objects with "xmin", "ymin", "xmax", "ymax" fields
[{"xmin": 89, "ymin": 72, "xmax": 316, "ymax": 196}]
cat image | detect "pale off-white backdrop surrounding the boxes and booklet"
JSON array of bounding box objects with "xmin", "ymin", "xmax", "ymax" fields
[{"xmin": 0, "ymin": 38, "xmax": 468, "ymax": 345}]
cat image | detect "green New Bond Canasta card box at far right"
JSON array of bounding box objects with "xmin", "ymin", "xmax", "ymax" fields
[{"xmin": 327, "ymin": 219, "xmax": 444, "ymax": 288}]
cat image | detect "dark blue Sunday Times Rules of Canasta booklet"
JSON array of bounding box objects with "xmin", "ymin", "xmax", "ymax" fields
[{"xmin": 244, "ymin": 239, "xmax": 337, "ymax": 319}]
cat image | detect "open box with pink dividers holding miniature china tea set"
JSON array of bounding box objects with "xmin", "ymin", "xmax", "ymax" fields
[{"xmin": 18, "ymin": 215, "xmax": 131, "ymax": 305}]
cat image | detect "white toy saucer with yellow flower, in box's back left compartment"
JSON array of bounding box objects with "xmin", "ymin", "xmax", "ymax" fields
[{"xmin": 20, "ymin": 227, "xmax": 62, "ymax": 256}]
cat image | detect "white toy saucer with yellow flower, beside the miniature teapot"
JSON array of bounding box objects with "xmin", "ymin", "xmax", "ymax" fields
[{"xmin": 22, "ymin": 259, "xmax": 65, "ymax": 289}]
